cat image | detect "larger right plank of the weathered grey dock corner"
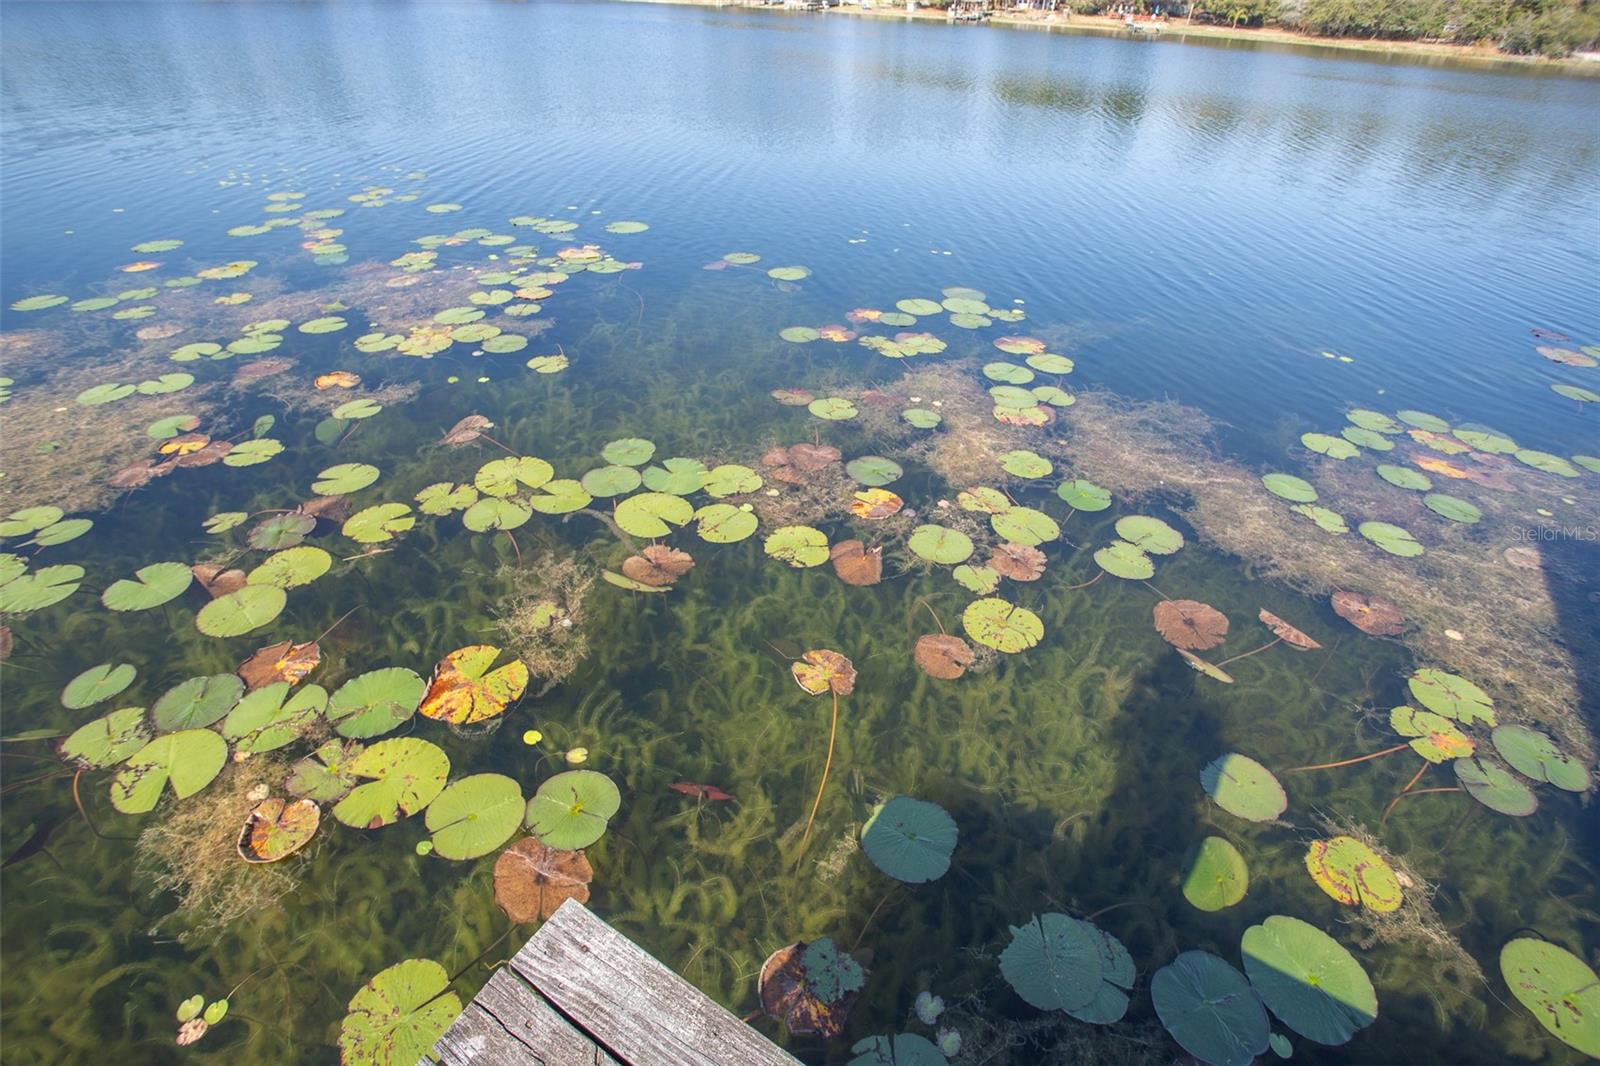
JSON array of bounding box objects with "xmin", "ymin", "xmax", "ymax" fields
[{"xmin": 510, "ymin": 900, "xmax": 798, "ymax": 1066}]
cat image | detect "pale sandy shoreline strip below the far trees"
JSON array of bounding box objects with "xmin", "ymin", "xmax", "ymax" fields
[{"xmin": 621, "ymin": 0, "xmax": 1600, "ymax": 77}]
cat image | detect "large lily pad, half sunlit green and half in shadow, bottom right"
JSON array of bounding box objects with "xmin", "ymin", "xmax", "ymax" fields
[{"xmin": 1240, "ymin": 914, "xmax": 1378, "ymax": 1045}]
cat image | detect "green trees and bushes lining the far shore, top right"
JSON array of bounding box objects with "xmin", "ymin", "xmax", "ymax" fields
[{"xmin": 923, "ymin": 0, "xmax": 1600, "ymax": 58}]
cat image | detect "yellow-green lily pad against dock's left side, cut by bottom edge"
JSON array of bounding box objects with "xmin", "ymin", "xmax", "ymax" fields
[{"xmin": 339, "ymin": 959, "xmax": 461, "ymax": 1066}]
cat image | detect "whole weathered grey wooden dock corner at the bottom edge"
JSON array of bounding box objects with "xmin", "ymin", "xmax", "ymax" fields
[{"xmin": 434, "ymin": 900, "xmax": 798, "ymax": 1066}]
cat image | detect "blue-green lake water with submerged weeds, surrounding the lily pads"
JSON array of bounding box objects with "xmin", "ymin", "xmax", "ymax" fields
[{"xmin": 0, "ymin": 3, "xmax": 1600, "ymax": 1063}]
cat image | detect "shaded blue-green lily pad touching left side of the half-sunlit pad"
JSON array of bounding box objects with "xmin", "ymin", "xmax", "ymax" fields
[{"xmin": 1150, "ymin": 951, "xmax": 1272, "ymax": 1066}]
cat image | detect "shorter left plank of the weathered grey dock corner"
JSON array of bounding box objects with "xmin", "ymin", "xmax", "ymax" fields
[{"xmin": 434, "ymin": 970, "xmax": 621, "ymax": 1066}]
